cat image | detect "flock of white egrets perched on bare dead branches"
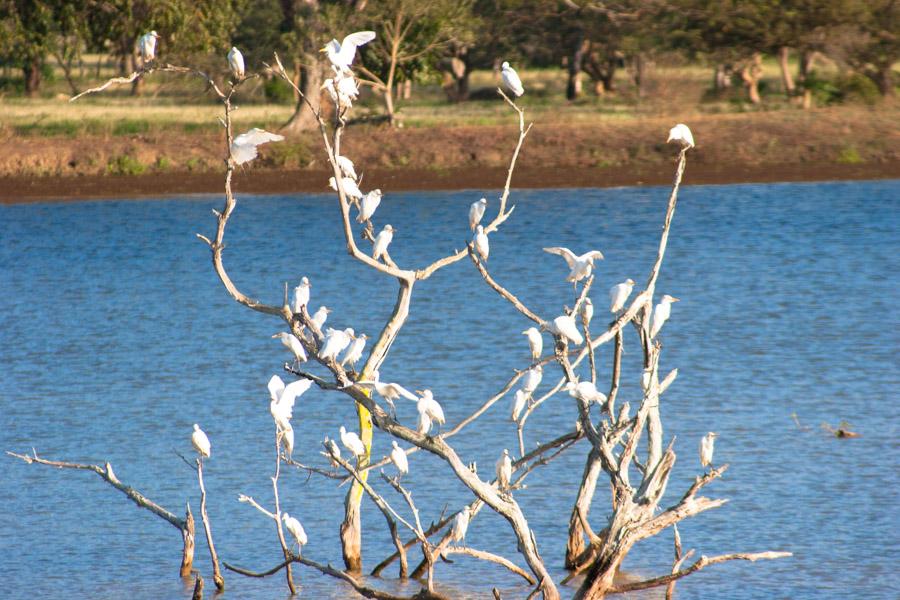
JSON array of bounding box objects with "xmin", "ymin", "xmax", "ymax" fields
[{"xmin": 172, "ymin": 25, "xmax": 717, "ymax": 549}]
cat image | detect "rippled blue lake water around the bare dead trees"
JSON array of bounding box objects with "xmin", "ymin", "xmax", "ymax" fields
[{"xmin": 0, "ymin": 182, "xmax": 900, "ymax": 600}]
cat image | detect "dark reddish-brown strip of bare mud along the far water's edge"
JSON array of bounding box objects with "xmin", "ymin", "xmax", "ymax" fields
[{"xmin": 0, "ymin": 161, "xmax": 900, "ymax": 205}]
